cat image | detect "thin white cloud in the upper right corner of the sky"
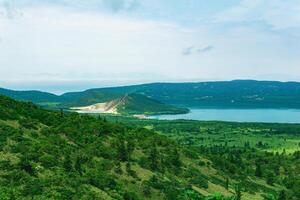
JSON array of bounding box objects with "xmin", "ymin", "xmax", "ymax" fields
[{"xmin": 215, "ymin": 0, "xmax": 300, "ymax": 29}]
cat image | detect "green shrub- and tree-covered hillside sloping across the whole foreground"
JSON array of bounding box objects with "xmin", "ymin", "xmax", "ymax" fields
[{"xmin": 0, "ymin": 96, "xmax": 300, "ymax": 200}]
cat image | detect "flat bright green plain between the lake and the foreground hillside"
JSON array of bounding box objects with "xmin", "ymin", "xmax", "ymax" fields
[{"xmin": 105, "ymin": 115, "xmax": 300, "ymax": 153}]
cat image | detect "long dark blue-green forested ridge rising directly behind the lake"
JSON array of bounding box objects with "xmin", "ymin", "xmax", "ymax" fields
[{"xmin": 83, "ymin": 80, "xmax": 300, "ymax": 108}]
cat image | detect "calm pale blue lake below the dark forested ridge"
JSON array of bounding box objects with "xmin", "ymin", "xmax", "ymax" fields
[{"xmin": 150, "ymin": 109, "xmax": 300, "ymax": 123}]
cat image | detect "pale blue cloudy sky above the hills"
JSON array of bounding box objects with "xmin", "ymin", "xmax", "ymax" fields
[{"xmin": 0, "ymin": 0, "xmax": 300, "ymax": 93}]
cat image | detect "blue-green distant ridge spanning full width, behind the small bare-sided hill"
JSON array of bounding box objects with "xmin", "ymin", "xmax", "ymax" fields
[{"xmin": 0, "ymin": 80, "xmax": 300, "ymax": 109}]
